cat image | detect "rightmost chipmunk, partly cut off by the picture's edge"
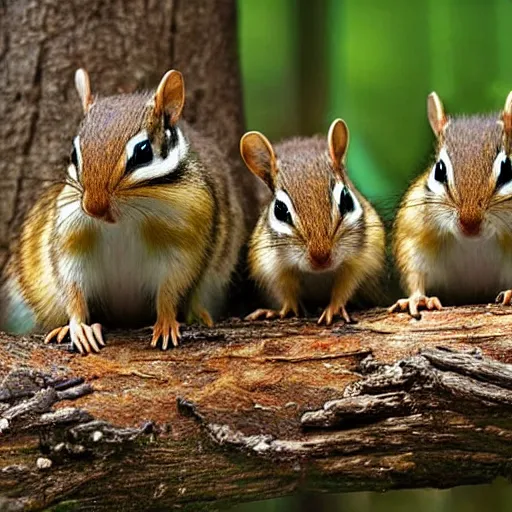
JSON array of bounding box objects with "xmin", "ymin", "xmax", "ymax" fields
[{"xmin": 390, "ymin": 92, "xmax": 512, "ymax": 318}]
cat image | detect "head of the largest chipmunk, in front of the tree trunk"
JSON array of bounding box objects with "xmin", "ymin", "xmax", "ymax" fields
[{"xmin": 68, "ymin": 69, "xmax": 188, "ymax": 222}]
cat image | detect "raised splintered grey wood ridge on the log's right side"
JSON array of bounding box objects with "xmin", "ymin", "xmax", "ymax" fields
[{"xmin": 178, "ymin": 349, "xmax": 512, "ymax": 457}]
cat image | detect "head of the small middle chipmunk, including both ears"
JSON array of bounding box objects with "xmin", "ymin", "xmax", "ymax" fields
[{"xmin": 240, "ymin": 119, "xmax": 364, "ymax": 272}]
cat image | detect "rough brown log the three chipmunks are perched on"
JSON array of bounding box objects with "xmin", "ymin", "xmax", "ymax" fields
[{"xmin": 0, "ymin": 306, "xmax": 512, "ymax": 511}]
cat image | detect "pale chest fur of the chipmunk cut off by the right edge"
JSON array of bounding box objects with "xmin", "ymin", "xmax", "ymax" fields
[{"xmin": 426, "ymin": 237, "xmax": 512, "ymax": 305}]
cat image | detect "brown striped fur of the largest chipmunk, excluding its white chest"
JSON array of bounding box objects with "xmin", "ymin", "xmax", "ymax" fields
[{"xmin": 1, "ymin": 72, "xmax": 246, "ymax": 344}]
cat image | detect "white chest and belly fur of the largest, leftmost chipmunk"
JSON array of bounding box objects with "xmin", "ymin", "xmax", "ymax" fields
[{"xmin": 58, "ymin": 199, "xmax": 180, "ymax": 319}]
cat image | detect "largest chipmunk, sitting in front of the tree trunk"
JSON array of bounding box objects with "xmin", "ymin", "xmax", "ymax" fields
[{"xmin": 4, "ymin": 69, "xmax": 245, "ymax": 353}]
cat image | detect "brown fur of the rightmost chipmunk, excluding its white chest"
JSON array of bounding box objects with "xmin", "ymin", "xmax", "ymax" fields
[{"xmin": 393, "ymin": 99, "xmax": 510, "ymax": 304}]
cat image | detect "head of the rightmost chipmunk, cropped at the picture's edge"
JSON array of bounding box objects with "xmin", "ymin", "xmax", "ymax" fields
[{"xmin": 426, "ymin": 92, "xmax": 512, "ymax": 237}]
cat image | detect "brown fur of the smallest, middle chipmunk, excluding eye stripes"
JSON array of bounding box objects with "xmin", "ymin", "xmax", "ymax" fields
[{"xmin": 244, "ymin": 125, "xmax": 384, "ymax": 324}]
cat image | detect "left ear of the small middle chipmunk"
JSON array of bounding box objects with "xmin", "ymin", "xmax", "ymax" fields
[{"xmin": 240, "ymin": 132, "xmax": 277, "ymax": 190}]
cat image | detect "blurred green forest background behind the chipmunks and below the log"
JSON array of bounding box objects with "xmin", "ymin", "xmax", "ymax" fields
[{"xmin": 238, "ymin": 0, "xmax": 512, "ymax": 512}]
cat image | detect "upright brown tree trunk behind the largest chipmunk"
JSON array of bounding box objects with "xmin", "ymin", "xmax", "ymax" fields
[{"xmin": 0, "ymin": 0, "xmax": 262, "ymax": 268}]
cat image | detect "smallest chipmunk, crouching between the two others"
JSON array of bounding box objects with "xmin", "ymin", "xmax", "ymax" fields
[{"xmin": 240, "ymin": 119, "xmax": 385, "ymax": 325}]
